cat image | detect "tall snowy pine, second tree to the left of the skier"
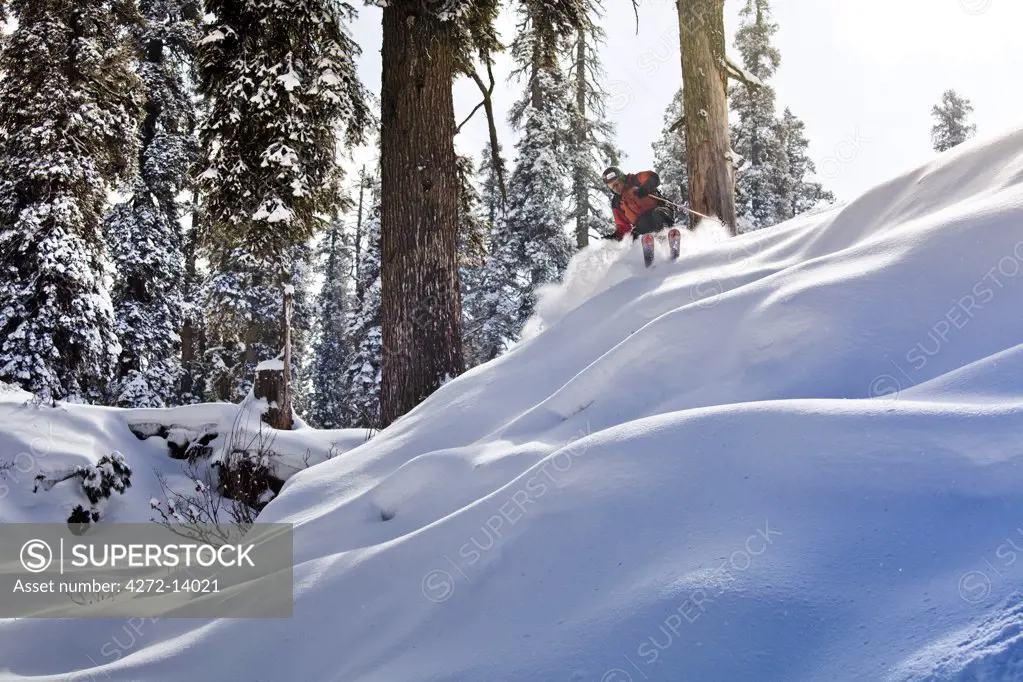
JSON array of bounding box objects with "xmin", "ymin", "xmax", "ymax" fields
[{"xmin": 501, "ymin": 2, "xmax": 573, "ymax": 328}]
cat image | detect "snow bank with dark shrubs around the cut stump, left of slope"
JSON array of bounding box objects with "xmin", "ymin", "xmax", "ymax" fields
[{"xmin": 0, "ymin": 390, "xmax": 366, "ymax": 524}]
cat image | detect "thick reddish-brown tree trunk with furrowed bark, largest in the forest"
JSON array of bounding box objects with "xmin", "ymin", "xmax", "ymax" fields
[{"xmin": 381, "ymin": 0, "xmax": 464, "ymax": 426}]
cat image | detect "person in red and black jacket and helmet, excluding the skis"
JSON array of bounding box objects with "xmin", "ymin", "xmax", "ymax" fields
[{"xmin": 604, "ymin": 166, "xmax": 675, "ymax": 241}]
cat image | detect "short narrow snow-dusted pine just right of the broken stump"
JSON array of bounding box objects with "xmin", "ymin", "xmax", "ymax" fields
[{"xmin": 310, "ymin": 219, "xmax": 352, "ymax": 428}]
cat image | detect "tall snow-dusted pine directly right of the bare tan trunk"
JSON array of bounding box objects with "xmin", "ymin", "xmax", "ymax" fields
[{"xmin": 730, "ymin": 0, "xmax": 792, "ymax": 229}]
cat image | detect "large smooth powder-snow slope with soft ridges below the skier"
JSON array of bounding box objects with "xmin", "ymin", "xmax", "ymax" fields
[{"xmin": 6, "ymin": 131, "xmax": 1023, "ymax": 682}]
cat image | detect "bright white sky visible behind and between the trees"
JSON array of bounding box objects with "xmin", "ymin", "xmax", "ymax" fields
[{"xmin": 345, "ymin": 0, "xmax": 1023, "ymax": 199}]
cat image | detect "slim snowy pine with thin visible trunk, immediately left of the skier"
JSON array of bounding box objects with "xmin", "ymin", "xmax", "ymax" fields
[{"xmin": 568, "ymin": 3, "xmax": 621, "ymax": 248}]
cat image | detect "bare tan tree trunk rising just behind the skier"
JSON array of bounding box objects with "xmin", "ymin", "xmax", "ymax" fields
[{"xmin": 675, "ymin": 0, "xmax": 736, "ymax": 234}]
